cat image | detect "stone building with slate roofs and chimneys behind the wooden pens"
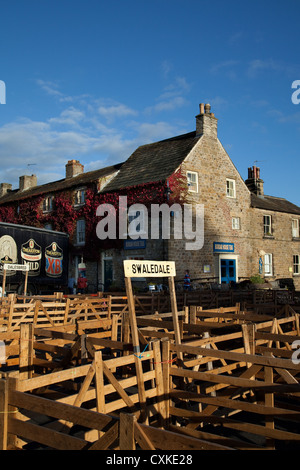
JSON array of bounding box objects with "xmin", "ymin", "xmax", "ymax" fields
[{"xmin": 0, "ymin": 104, "xmax": 300, "ymax": 288}]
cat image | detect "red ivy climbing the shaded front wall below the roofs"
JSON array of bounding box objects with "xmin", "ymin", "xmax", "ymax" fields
[{"xmin": 0, "ymin": 169, "xmax": 187, "ymax": 258}]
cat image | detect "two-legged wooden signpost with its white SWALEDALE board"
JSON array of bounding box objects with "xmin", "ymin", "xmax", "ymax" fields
[{"xmin": 123, "ymin": 260, "xmax": 182, "ymax": 422}]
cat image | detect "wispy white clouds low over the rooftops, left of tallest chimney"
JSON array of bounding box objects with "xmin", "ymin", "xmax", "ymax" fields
[{"xmin": 0, "ymin": 78, "xmax": 188, "ymax": 188}]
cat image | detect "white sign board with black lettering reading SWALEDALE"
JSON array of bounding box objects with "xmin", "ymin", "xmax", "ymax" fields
[{"xmin": 123, "ymin": 260, "xmax": 176, "ymax": 277}]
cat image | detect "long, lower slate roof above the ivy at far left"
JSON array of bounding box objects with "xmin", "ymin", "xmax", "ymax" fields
[{"xmin": 0, "ymin": 163, "xmax": 123, "ymax": 205}]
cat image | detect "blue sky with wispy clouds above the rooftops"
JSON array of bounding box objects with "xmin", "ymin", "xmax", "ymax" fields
[{"xmin": 0, "ymin": 0, "xmax": 300, "ymax": 205}]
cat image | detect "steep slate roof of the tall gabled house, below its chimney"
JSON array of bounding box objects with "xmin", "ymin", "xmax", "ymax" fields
[{"xmin": 103, "ymin": 131, "xmax": 200, "ymax": 192}]
